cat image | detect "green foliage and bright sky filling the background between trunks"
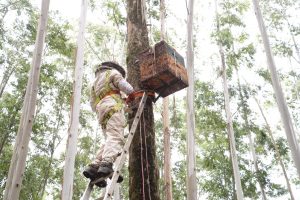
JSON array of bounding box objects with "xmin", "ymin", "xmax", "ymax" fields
[{"xmin": 0, "ymin": 0, "xmax": 300, "ymax": 200}]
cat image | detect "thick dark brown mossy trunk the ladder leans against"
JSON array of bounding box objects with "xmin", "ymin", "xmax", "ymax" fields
[{"xmin": 127, "ymin": 0, "xmax": 160, "ymax": 200}]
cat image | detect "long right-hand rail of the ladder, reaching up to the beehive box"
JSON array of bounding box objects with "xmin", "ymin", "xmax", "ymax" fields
[{"xmin": 104, "ymin": 92, "xmax": 148, "ymax": 200}]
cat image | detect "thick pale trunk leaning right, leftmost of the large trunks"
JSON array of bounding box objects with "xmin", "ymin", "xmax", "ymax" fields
[{"xmin": 4, "ymin": 0, "xmax": 49, "ymax": 200}]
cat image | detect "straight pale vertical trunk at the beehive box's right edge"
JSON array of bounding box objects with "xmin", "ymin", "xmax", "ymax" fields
[{"xmin": 186, "ymin": 0, "xmax": 197, "ymax": 200}]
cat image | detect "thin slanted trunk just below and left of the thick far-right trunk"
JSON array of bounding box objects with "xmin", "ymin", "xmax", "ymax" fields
[{"xmin": 254, "ymin": 96, "xmax": 295, "ymax": 200}]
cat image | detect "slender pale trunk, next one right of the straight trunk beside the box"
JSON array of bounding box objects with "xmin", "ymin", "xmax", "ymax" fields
[{"xmin": 215, "ymin": 0, "xmax": 244, "ymax": 200}]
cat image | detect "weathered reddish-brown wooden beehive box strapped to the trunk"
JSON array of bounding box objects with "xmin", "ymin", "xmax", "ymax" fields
[{"xmin": 138, "ymin": 41, "xmax": 188, "ymax": 97}]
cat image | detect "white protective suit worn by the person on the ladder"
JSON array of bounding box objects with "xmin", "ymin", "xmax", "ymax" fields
[{"xmin": 90, "ymin": 67, "xmax": 134, "ymax": 165}]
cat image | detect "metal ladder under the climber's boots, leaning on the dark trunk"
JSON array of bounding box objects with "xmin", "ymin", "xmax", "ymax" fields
[{"xmin": 80, "ymin": 92, "xmax": 148, "ymax": 200}]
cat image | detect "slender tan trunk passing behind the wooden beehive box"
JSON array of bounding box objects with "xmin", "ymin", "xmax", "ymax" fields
[{"xmin": 160, "ymin": 0, "xmax": 173, "ymax": 200}]
